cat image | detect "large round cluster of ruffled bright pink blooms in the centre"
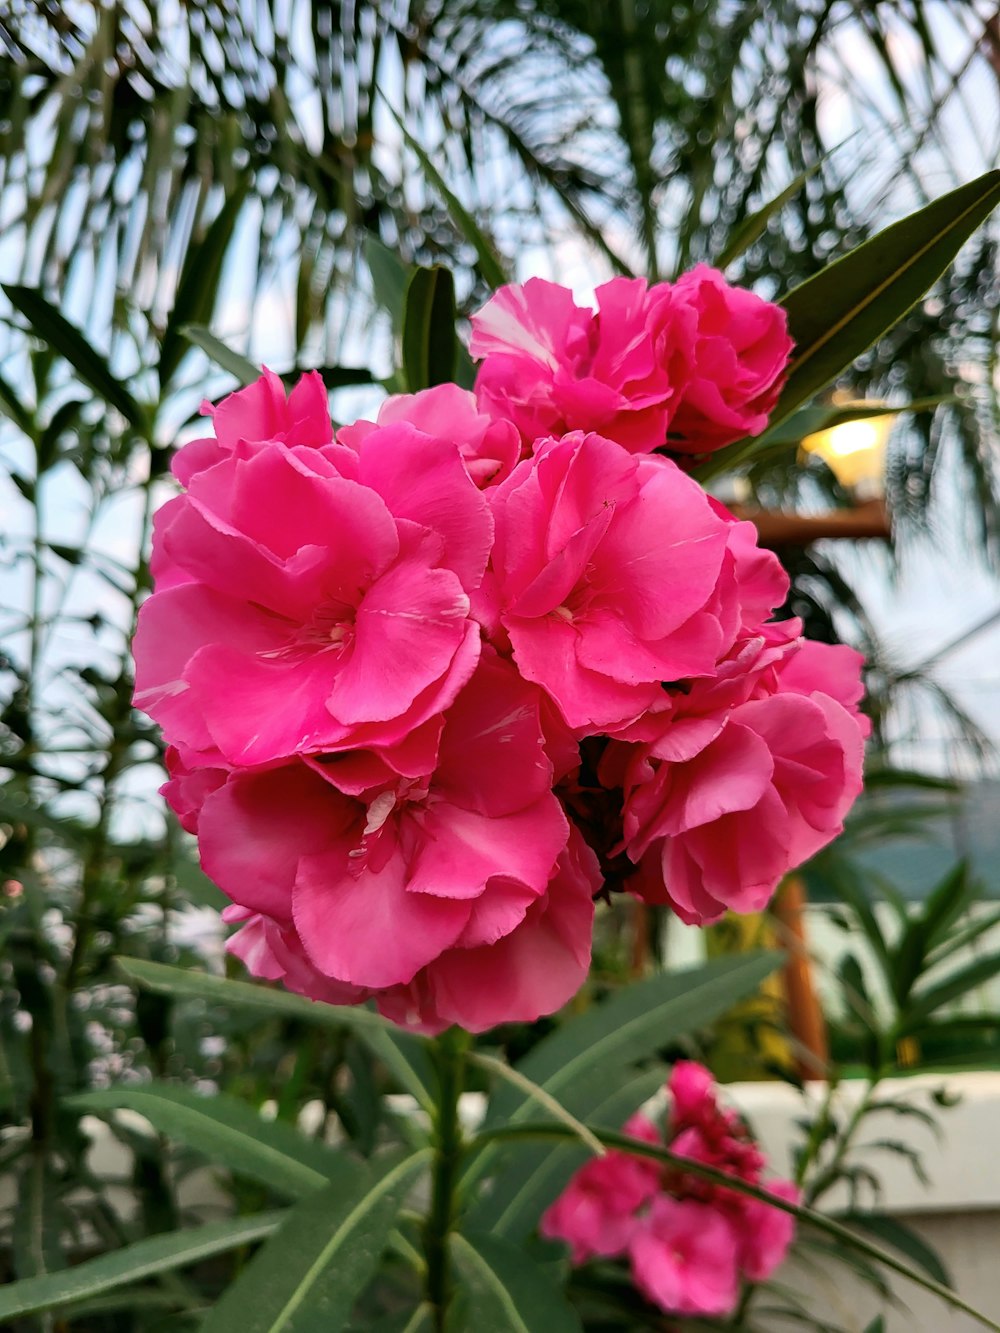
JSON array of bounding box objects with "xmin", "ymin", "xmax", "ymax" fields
[{"xmin": 135, "ymin": 268, "xmax": 863, "ymax": 1030}]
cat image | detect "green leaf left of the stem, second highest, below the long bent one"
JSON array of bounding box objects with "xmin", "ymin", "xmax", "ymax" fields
[{"xmin": 68, "ymin": 1082, "xmax": 344, "ymax": 1198}]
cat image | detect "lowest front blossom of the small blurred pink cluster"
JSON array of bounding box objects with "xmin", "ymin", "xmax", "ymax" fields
[{"xmin": 628, "ymin": 1194, "xmax": 739, "ymax": 1314}]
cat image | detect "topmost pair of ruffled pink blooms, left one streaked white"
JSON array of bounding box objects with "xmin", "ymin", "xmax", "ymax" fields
[{"xmin": 469, "ymin": 264, "xmax": 792, "ymax": 453}]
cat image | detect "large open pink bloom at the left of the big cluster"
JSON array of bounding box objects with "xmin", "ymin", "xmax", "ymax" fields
[{"xmin": 135, "ymin": 424, "xmax": 492, "ymax": 770}]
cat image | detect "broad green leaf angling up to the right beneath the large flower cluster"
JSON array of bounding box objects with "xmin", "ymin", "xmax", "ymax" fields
[{"xmin": 484, "ymin": 953, "xmax": 781, "ymax": 1125}]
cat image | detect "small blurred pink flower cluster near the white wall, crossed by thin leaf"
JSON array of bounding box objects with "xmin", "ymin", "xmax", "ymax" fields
[{"xmin": 540, "ymin": 1061, "xmax": 799, "ymax": 1316}]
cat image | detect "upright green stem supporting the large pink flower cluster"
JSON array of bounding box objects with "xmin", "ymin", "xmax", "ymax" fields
[{"xmin": 424, "ymin": 1028, "xmax": 468, "ymax": 1333}]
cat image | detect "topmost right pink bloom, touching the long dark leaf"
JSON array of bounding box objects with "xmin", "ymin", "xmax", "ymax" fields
[{"xmin": 669, "ymin": 264, "xmax": 795, "ymax": 453}]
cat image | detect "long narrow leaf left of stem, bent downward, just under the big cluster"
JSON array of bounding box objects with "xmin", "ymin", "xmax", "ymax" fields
[{"xmin": 116, "ymin": 958, "xmax": 435, "ymax": 1110}]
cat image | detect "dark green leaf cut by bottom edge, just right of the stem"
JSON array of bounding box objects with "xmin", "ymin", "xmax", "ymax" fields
[{"xmin": 445, "ymin": 1232, "xmax": 583, "ymax": 1333}]
